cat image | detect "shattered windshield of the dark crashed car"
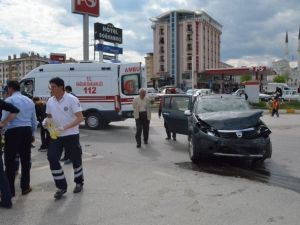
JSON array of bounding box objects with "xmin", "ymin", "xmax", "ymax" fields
[{"xmin": 196, "ymin": 97, "xmax": 250, "ymax": 113}]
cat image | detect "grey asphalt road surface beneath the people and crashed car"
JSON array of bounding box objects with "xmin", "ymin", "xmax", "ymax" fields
[{"xmin": 0, "ymin": 114, "xmax": 300, "ymax": 225}]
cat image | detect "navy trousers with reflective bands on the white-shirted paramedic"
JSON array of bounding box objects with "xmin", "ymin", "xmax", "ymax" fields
[{"xmin": 48, "ymin": 134, "xmax": 84, "ymax": 189}]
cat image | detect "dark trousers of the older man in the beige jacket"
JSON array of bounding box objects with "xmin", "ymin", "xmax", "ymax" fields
[{"xmin": 135, "ymin": 112, "xmax": 150, "ymax": 145}]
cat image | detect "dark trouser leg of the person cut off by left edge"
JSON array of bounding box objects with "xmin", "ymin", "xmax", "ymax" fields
[{"xmin": 0, "ymin": 152, "xmax": 11, "ymax": 205}]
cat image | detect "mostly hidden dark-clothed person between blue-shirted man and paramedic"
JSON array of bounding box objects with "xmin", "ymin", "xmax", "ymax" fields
[{"xmin": 33, "ymin": 97, "xmax": 50, "ymax": 152}]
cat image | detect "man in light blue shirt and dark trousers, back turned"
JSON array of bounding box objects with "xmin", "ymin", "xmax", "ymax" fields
[{"xmin": 2, "ymin": 81, "xmax": 37, "ymax": 196}]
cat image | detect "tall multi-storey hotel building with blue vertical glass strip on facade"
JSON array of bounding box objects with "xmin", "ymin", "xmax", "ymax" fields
[{"xmin": 151, "ymin": 10, "xmax": 222, "ymax": 87}]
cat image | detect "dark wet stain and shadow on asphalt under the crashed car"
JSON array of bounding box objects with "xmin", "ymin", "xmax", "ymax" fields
[{"xmin": 176, "ymin": 157, "xmax": 300, "ymax": 193}]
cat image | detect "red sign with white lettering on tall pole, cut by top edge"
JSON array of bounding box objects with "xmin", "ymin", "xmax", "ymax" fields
[{"xmin": 72, "ymin": 0, "xmax": 100, "ymax": 17}]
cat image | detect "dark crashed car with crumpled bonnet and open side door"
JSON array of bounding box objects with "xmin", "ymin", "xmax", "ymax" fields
[{"xmin": 162, "ymin": 94, "xmax": 272, "ymax": 163}]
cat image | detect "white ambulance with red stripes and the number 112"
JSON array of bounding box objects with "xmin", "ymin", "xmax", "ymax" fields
[{"xmin": 20, "ymin": 63, "xmax": 142, "ymax": 129}]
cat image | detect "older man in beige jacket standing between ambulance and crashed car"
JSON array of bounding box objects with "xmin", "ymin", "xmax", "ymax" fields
[{"xmin": 132, "ymin": 88, "xmax": 151, "ymax": 148}]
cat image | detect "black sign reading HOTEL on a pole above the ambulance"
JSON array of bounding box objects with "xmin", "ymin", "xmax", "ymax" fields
[{"xmin": 94, "ymin": 23, "xmax": 123, "ymax": 44}]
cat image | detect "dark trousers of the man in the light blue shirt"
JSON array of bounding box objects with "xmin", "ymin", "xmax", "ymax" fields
[{"xmin": 4, "ymin": 127, "xmax": 32, "ymax": 196}]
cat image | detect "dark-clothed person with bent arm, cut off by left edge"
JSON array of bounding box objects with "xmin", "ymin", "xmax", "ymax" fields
[{"xmin": 0, "ymin": 100, "xmax": 19, "ymax": 208}]
